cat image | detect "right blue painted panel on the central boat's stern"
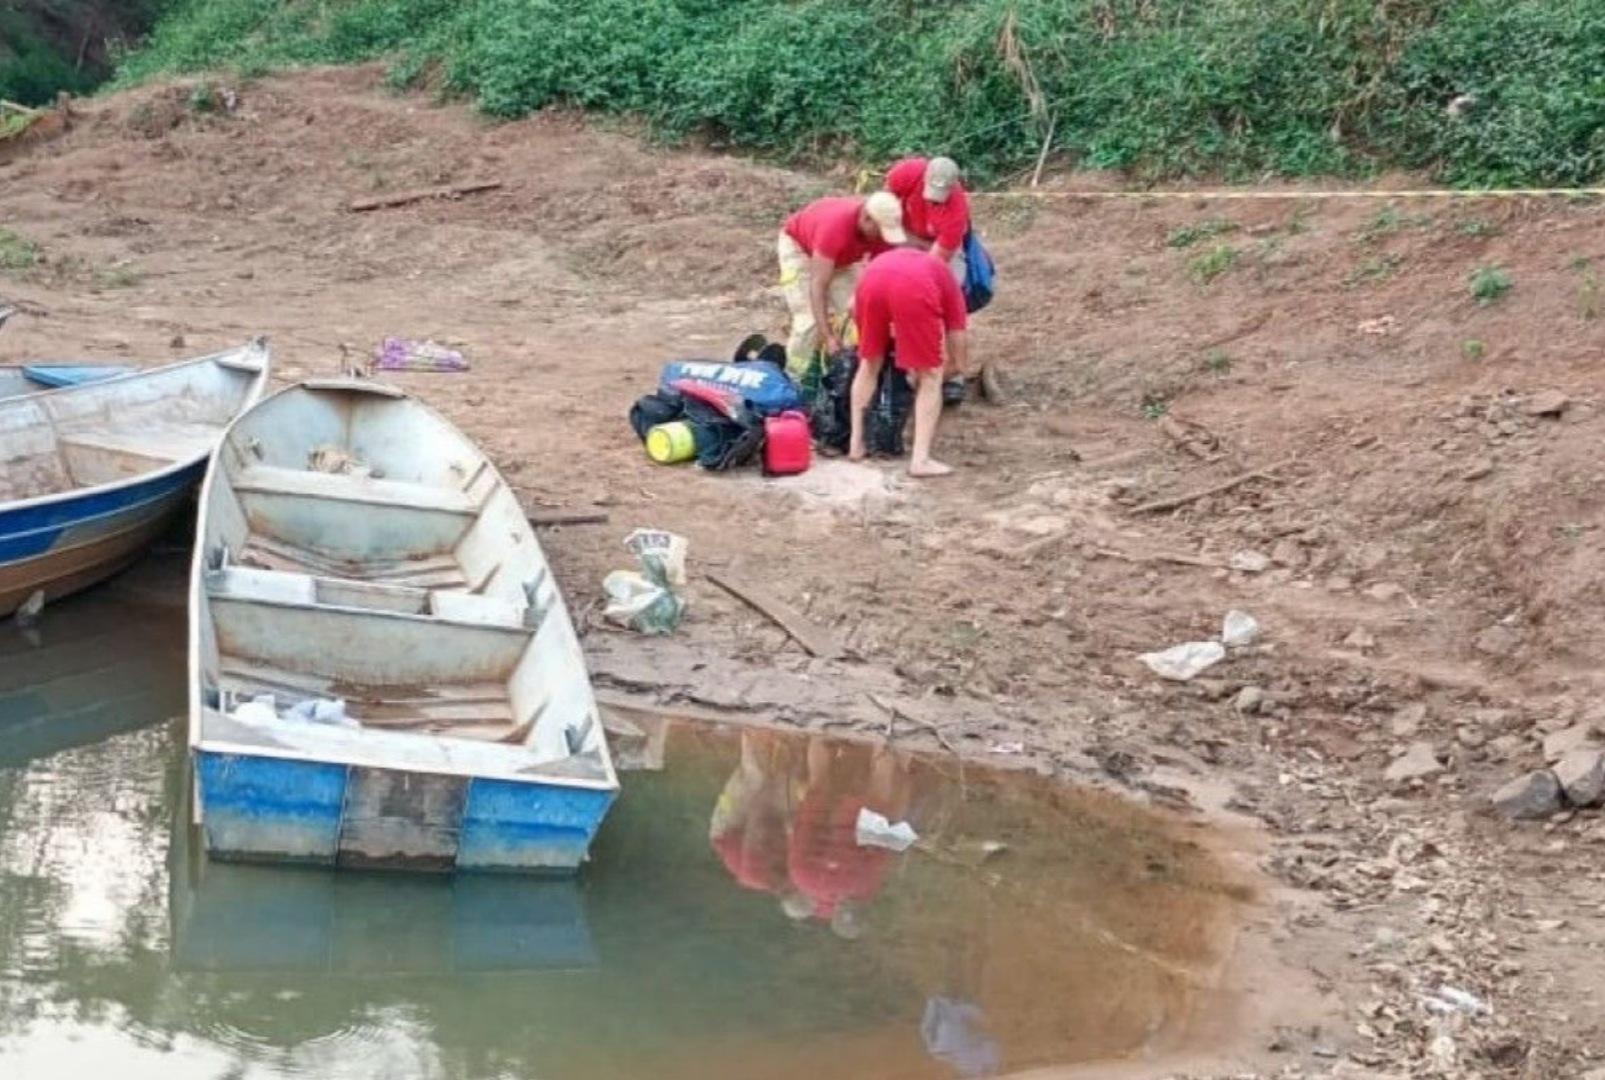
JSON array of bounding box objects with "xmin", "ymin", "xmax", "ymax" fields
[{"xmin": 457, "ymin": 780, "xmax": 615, "ymax": 870}]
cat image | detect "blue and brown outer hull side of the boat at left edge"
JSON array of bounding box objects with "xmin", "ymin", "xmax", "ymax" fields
[{"xmin": 0, "ymin": 462, "xmax": 205, "ymax": 618}]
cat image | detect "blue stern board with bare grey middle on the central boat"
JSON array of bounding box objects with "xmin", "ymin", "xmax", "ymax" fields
[{"xmin": 196, "ymin": 749, "xmax": 615, "ymax": 873}]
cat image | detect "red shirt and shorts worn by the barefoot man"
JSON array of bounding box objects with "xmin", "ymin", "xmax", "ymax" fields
[{"xmin": 852, "ymin": 247, "xmax": 969, "ymax": 371}]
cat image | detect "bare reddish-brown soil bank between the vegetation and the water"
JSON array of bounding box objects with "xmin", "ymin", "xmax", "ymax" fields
[{"xmin": 0, "ymin": 69, "xmax": 1605, "ymax": 1077}]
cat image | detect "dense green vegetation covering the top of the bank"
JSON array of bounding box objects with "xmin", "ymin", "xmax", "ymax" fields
[{"xmin": 120, "ymin": 0, "xmax": 1605, "ymax": 185}]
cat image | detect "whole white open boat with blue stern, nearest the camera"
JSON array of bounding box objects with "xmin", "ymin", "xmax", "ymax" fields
[{"xmin": 189, "ymin": 379, "xmax": 618, "ymax": 871}]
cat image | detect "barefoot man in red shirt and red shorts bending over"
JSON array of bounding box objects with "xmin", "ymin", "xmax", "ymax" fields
[{"xmin": 847, "ymin": 247, "xmax": 969, "ymax": 477}]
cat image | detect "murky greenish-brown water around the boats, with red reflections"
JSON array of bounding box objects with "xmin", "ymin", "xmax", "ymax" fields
[{"xmin": 0, "ymin": 552, "xmax": 1241, "ymax": 1080}]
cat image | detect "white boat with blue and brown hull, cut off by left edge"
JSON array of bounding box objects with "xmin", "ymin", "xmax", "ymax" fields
[{"xmin": 0, "ymin": 343, "xmax": 268, "ymax": 616}]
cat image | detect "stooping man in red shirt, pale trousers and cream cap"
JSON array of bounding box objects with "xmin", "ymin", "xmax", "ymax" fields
[{"xmin": 777, "ymin": 191, "xmax": 908, "ymax": 377}]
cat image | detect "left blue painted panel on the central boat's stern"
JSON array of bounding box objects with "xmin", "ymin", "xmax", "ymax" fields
[{"xmin": 196, "ymin": 751, "xmax": 347, "ymax": 863}]
